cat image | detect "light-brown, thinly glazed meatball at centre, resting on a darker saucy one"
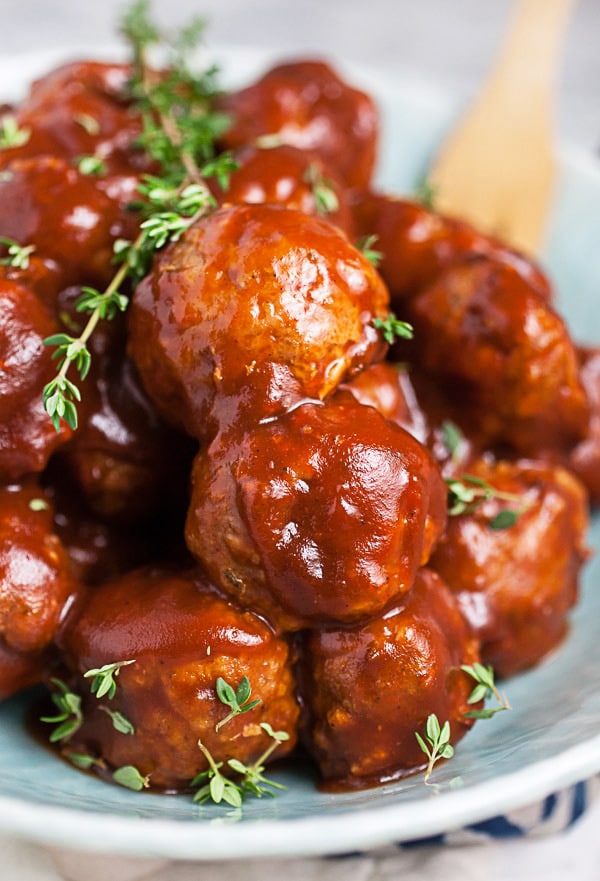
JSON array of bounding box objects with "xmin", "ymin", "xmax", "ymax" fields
[{"xmin": 129, "ymin": 205, "xmax": 388, "ymax": 439}]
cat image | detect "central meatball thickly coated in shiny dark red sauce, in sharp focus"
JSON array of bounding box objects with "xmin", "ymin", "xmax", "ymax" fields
[{"xmin": 186, "ymin": 392, "xmax": 446, "ymax": 630}]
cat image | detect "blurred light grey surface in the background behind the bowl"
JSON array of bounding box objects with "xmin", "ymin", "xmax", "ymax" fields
[{"xmin": 0, "ymin": 0, "xmax": 600, "ymax": 148}]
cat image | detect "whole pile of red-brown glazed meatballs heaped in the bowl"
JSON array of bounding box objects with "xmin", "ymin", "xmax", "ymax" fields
[{"xmin": 0, "ymin": 60, "xmax": 600, "ymax": 791}]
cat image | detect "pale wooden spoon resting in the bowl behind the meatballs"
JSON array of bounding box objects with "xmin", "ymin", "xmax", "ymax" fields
[{"xmin": 429, "ymin": 0, "xmax": 575, "ymax": 254}]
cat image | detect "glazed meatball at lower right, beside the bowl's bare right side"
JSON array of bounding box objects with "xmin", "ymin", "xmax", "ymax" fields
[{"xmin": 430, "ymin": 462, "xmax": 588, "ymax": 676}]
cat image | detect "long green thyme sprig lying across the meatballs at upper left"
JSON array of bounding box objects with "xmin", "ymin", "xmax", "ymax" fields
[{"xmin": 41, "ymin": 0, "xmax": 234, "ymax": 431}]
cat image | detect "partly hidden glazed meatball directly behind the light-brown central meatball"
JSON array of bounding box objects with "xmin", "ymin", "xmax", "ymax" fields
[{"xmin": 213, "ymin": 144, "xmax": 352, "ymax": 235}]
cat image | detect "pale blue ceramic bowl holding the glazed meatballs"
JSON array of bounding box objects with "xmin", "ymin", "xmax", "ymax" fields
[{"xmin": 0, "ymin": 47, "xmax": 600, "ymax": 859}]
